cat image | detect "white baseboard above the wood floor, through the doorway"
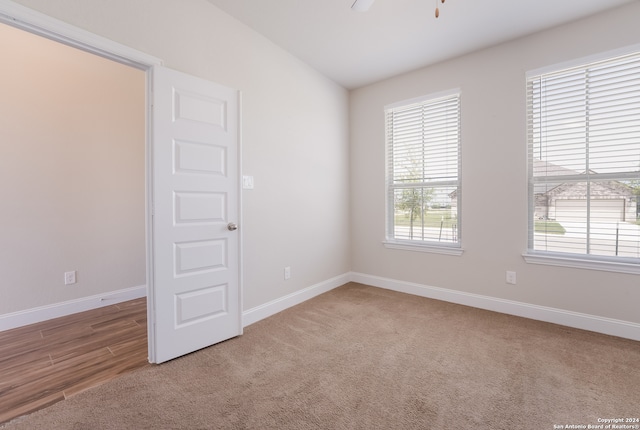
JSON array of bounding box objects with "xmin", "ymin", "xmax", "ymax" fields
[{"xmin": 0, "ymin": 285, "xmax": 147, "ymax": 331}]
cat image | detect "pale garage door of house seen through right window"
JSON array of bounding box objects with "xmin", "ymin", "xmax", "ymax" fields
[{"xmin": 556, "ymin": 199, "xmax": 624, "ymax": 222}]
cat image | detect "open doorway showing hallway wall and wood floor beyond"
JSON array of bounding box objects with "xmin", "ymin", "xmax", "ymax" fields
[{"xmin": 0, "ymin": 22, "xmax": 148, "ymax": 425}]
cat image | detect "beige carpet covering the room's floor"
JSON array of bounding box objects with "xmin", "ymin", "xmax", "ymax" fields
[{"xmin": 0, "ymin": 284, "xmax": 640, "ymax": 430}]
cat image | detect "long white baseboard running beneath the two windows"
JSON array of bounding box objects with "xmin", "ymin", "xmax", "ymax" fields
[{"xmin": 350, "ymin": 272, "xmax": 640, "ymax": 340}]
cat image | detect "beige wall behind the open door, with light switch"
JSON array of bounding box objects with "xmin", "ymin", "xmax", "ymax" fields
[{"xmin": 3, "ymin": 0, "xmax": 350, "ymax": 316}]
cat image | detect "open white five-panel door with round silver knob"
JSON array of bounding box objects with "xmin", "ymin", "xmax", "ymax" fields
[{"xmin": 149, "ymin": 67, "xmax": 242, "ymax": 363}]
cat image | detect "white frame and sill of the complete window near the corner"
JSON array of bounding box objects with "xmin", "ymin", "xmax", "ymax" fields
[{"xmin": 382, "ymin": 88, "xmax": 464, "ymax": 256}]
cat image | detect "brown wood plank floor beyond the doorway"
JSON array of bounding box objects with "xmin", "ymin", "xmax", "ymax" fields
[{"xmin": 0, "ymin": 298, "xmax": 150, "ymax": 424}]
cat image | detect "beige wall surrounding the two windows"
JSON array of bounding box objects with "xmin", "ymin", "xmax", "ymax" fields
[{"xmin": 350, "ymin": 2, "xmax": 640, "ymax": 323}]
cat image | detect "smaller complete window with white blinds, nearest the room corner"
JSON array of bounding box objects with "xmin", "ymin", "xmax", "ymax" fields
[{"xmin": 385, "ymin": 91, "xmax": 461, "ymax": 254}]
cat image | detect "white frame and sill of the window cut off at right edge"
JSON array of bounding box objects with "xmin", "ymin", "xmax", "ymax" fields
[{"xmin": 522, "ymin": 44, "xmax": 640, "ymax": 274}]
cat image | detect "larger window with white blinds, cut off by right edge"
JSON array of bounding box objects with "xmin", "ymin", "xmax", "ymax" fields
[{"xmin": 527, "ymin": 49, "xmax": 640, "ymax": 273}]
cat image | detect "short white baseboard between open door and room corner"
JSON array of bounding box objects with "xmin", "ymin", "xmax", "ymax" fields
[{"xmin": 242, "ymin": 273, "xmax": 350, "ymax": 327}]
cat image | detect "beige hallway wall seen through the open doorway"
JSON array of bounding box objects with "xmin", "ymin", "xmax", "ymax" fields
[{"xmin": 0, "ymin": 24, "xmax": 146, "ymax": 315}]
